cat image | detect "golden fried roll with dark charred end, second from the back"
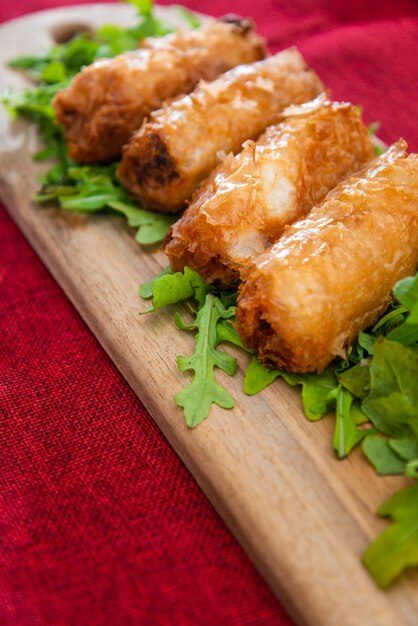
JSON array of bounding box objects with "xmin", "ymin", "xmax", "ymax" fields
[{"xmin": 119, "ymin": 48, "xmax": 324, "ymax": 213}]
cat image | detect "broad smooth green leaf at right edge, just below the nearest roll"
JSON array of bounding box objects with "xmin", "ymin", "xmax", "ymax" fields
[{"xmin": 362, "ymin": 338, "xmax": 418, "ymax": 437}]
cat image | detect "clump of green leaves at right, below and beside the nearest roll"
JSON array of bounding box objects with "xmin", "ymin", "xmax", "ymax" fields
[{"xmin": 240, "ymin": 274, "xmax": 418, "ymax": 587}]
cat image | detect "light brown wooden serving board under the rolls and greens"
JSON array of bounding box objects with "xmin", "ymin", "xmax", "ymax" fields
[{"xmin": 0, "ymin": 5, "xmax": 418, "ymax": 626}]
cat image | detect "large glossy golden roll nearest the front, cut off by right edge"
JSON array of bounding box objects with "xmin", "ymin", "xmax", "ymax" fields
[{"xmin": 237, "ymin": 141, "xmax": 418, "ymax": 372}]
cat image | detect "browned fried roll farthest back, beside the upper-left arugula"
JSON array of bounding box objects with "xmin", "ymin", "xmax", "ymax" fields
[{"xmin": 53, "ymin": 18, "xmax": 265, "ymax": 163}]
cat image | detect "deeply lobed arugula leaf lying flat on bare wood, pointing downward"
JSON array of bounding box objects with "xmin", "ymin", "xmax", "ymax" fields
[{"xmin": 174, "ymin": 294, "xmax": 237, "ymax": 428}]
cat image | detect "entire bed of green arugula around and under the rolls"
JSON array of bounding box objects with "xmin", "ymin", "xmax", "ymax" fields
[{"xmin": 2, "ymin": 0, "xmax": 418, "ymax": 587}]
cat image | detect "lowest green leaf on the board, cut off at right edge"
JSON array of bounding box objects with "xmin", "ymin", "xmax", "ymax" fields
[{"xmin": 363, "ymin": 483, "xmax": 418, "ymax": 588}]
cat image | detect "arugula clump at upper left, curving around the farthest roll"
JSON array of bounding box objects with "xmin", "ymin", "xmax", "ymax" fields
[{"xmin": 2, "ymin": 0, "xmax": 198, "ymax": 245}]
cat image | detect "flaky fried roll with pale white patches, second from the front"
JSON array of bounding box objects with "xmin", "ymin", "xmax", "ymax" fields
[{"xmin": 165, "ymin": 96, "xmax": 373, "ymax": 285}]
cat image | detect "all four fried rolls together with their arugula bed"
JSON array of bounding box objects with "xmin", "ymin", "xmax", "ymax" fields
[{"xmin": 3, "ymin": 0, "xmax": 418, "ymax": 587}]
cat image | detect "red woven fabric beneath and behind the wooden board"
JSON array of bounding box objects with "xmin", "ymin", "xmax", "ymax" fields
[{"xmin": 0, "ymin": 0, "xmax": 418, "ymax": 626}]
